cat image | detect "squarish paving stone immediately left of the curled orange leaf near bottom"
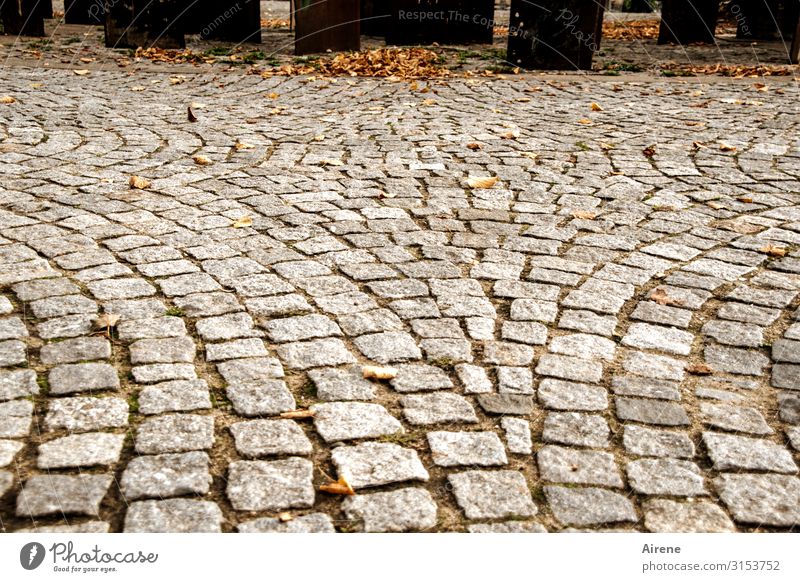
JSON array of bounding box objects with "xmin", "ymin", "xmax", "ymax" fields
[{"xmin": 226, "ymin": 458, "xmax": 314, "ymax": 511}]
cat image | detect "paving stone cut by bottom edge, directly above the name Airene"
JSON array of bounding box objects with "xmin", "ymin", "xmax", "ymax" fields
[{"xmin": 643, "ymin": 499, "xmax": 736, "ymax": 533}]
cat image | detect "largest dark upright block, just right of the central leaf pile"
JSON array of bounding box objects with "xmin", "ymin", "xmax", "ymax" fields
[{"xmin": 507, "ymin": 0, "xmax": 605, "ymax": 70}]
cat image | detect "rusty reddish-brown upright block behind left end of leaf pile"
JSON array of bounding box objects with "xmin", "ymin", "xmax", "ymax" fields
[{"xmin": 294, "ymin": 0, "xmax": 361, "ymax": 55}]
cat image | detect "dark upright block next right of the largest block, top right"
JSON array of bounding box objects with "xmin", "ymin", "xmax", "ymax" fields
[{"xmin": 658, "ymin": 0, "xmax": 719, "ymax": 44}]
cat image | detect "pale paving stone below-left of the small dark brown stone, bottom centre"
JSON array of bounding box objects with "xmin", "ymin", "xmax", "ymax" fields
[{"xmin": 428, "ymin": 431, "xmax": 508, "ymax": 467}]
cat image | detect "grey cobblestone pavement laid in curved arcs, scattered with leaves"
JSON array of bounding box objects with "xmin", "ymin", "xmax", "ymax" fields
[{"xmin": 0, "ymin": 68, "xmax": 800, "ymax": 532}]
